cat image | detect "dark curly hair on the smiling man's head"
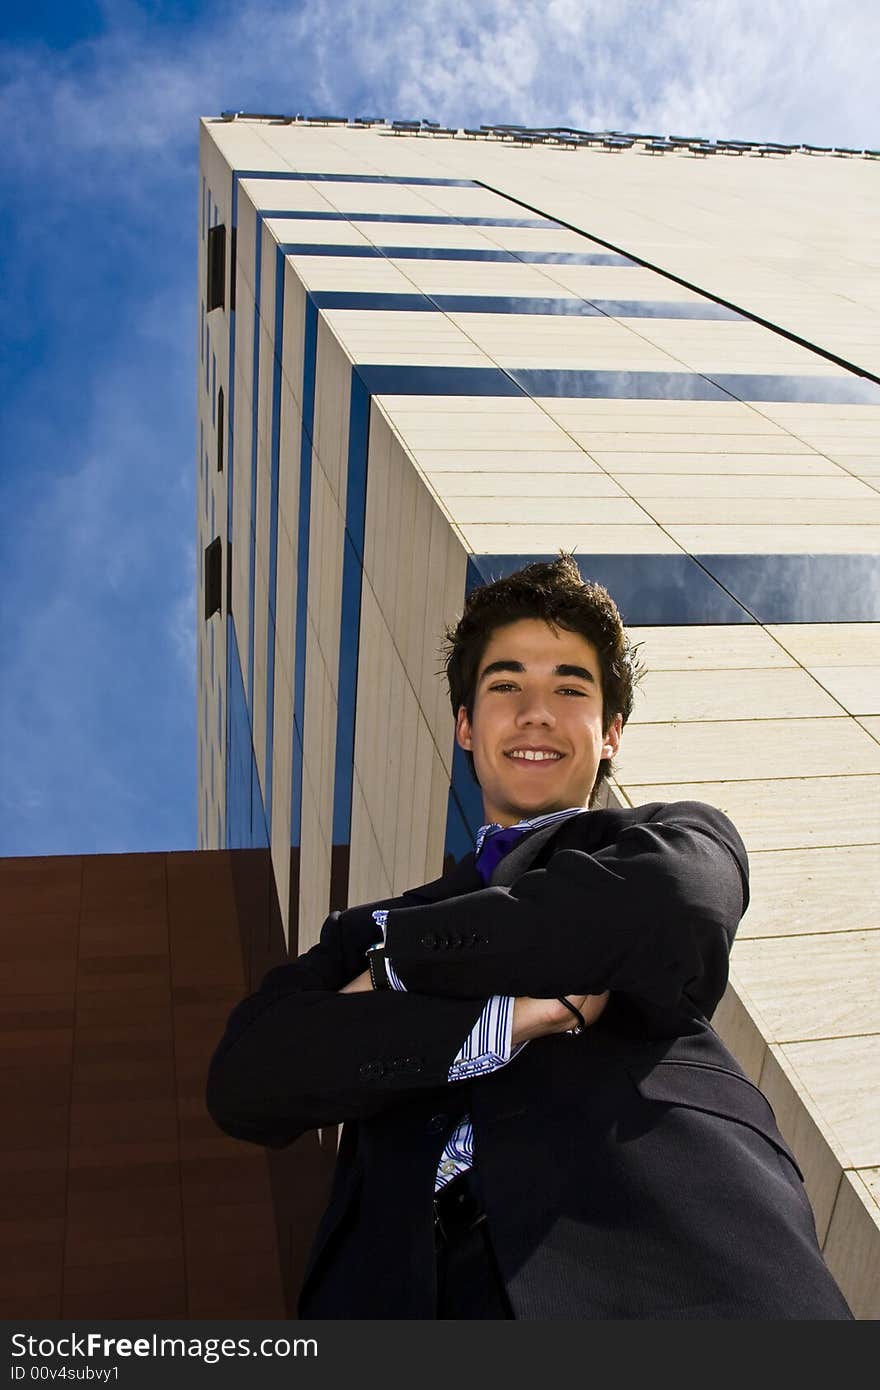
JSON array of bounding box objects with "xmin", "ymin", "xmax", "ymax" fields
[{"xmin": 443, "ymin": 550, "xmax": 645, "ymax": 806}]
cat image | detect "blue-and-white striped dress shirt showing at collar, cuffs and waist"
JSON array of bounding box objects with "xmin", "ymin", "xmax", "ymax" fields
[{"xmin": 373, "ymin": 806, "xmax": 584, "ymax": 1193}]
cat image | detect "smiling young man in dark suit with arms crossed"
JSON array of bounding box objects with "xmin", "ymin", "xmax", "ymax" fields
[{"xmin": 209, "ymin": 556, "xmax": 851, "ymax": 1319}]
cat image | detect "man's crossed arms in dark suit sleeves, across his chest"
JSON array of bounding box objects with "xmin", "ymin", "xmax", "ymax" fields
[{"xmin": 207, "ymin": 802, "xmax": 747, "ymax": 1147}]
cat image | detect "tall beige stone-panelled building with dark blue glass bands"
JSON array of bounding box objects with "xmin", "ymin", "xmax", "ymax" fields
[{"xmin": 189, "ymin": 113, "xmax": 880, "ymax": 1316}]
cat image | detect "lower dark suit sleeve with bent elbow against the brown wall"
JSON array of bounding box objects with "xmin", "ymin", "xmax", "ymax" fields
[{"xmin": 206, "ymin": 910, "xmax": 485, "ymax": 1148}]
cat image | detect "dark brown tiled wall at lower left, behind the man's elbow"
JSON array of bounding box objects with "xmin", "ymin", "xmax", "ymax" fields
[{"xmin": 0, "ymin": 851, "xmax": 335, "ymax": 1319}]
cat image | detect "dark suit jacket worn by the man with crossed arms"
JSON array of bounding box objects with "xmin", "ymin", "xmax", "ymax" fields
[{"xmin": 207, "ymin": 802, "xmax": 851, "ymax": 1319}]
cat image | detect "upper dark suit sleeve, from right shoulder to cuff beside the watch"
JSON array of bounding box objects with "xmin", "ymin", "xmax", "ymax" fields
[{"xmin": 385, "ymin": 802, "xmax": 748, "ymax": 1017}]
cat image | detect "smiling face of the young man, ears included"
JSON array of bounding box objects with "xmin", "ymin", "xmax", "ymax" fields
[{"xmin": 456, "ymin": 619, "xmax": 623, "ymax": 826}]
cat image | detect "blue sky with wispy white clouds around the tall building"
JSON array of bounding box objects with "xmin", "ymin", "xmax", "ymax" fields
[{"xmin": 0, "ymin": 0, "xmax": 880, "ymax": 855}]
